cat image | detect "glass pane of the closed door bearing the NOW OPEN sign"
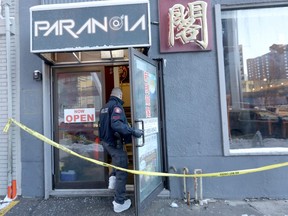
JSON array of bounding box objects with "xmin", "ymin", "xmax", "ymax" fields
[{"xmin": 53, "ymin": 68, "xmax": 108, "ymax": 189}]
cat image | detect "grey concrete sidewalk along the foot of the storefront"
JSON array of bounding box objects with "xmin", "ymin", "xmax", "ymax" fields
[{"xmin": 0, "ymin": 196, "xmax": 288, "ymax": 216}]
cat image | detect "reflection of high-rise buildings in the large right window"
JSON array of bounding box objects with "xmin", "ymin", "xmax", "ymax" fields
[{"xmin": 243, "ymin": 44, "xmax": 288, "ymax": 106}]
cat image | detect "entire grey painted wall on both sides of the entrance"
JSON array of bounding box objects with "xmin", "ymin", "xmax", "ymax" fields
[{"xmin": 20, "ymin": 0, "xmax": 288, "ymax": 199}]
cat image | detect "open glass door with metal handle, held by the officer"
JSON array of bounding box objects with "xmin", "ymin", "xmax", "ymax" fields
[{"xmin": 129, "ymin": 48, "xmax": 164, "ymax": 215}]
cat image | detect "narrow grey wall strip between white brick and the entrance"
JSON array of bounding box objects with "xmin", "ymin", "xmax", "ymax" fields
[{"xmin": 19, "ymin": 0, "xmax": 44, "ymax": 197}]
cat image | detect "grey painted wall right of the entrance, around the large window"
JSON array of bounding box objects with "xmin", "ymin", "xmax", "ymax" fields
[{"xmin": 149, "ymin": 0, "xmax": 288, "ymax": 198}]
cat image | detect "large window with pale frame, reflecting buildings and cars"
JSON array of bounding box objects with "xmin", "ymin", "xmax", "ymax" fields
[{"xmin": 215, "ymin": 5, "xmax": 288, "ymax": 154}]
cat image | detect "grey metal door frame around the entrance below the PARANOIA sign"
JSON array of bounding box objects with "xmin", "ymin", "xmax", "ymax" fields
[{"xmin": 42, "ymin": 50, "xmax": 169, "ymax": 201}]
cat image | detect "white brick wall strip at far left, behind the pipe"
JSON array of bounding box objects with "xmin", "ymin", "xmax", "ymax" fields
[{"xmin": 0, "ymin": 0, "xmax": 21, "ymax": 195}]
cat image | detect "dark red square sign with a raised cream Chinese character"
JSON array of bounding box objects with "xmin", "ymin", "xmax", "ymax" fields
[{"xmin": 159, "ymin": 0, "xmax": 212, "ymax": 52}]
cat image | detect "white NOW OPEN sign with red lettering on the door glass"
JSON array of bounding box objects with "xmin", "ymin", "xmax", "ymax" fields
[{"xmin": 64, "ymin": 108, "xmax": 96, "ymax": 123}]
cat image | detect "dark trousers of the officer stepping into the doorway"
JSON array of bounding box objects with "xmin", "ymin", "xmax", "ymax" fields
[{"xmin": 102, "ymin": 142, "xmax": 128, "ymax": 204}]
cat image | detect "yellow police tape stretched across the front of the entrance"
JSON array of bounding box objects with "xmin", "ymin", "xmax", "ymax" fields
[{"xmin": 3, "ymin": 118, "xmax": 288, "ymax": 178}]
